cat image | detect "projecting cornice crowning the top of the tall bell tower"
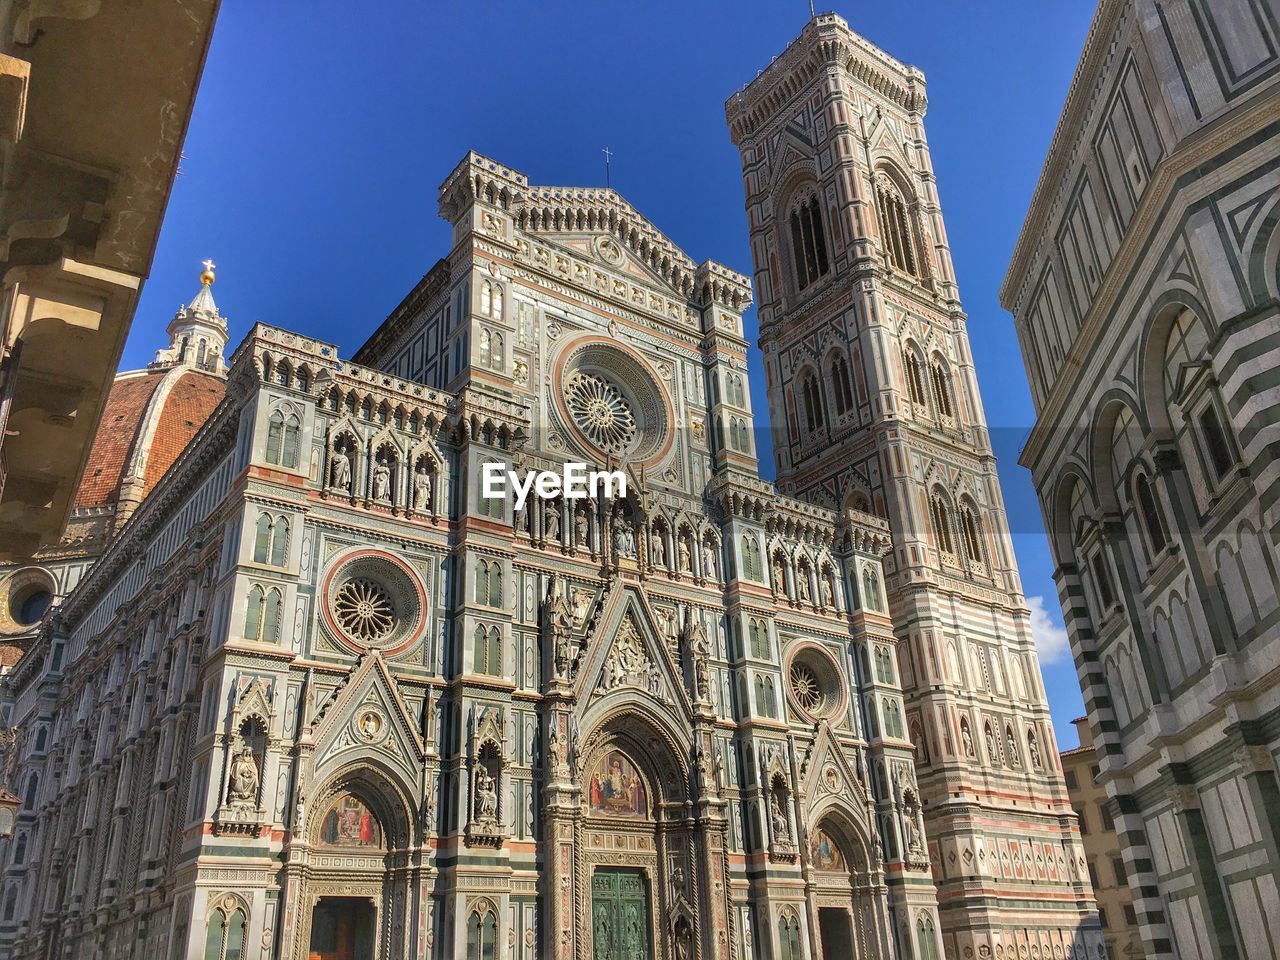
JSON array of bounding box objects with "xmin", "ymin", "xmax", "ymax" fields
[{"xmin": 724, "ymin": 13, "xmax": 927, "ymax": 145}]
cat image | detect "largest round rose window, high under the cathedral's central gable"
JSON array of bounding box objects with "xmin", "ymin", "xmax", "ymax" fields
[{"xmin": 554, "ymin": 339, "xmax": 671, "ymax": 461}]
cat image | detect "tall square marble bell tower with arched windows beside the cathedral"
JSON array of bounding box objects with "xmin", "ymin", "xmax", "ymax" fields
[{"xmin": 726, "ymin": 14, "xmax": 1101, "ymax": 957}]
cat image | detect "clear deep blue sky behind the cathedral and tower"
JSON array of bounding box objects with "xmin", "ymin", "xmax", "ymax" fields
[{"xmin": 123, "ymin": 0, "xmax": 1093, "ymax": 748}]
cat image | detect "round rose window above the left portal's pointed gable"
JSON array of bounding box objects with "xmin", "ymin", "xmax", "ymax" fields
[{"xmin": 323, "ymin": 550, "xmax": 426, "ymax": 655}]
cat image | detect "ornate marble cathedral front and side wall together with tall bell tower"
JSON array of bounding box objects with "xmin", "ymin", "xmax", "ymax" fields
[{"xmin": 0, "ymin": 15, "xmax": 1101, "ymax": 960}]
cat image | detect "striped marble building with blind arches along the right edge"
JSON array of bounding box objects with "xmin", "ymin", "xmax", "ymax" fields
[{"xmin": 1002, "ymin": 0, "xmax": 1280, "ymax": 960}]
